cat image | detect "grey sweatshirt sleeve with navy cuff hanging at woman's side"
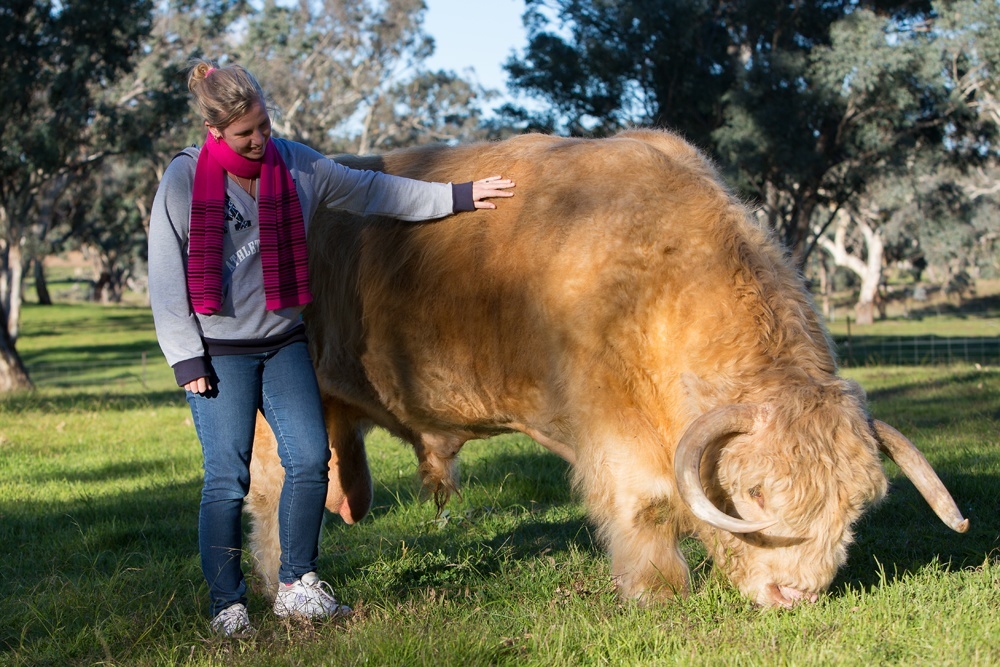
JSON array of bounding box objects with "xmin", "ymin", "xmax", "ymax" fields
[{"xmin": 148, "ymin": 153, "xmax": 208, "ymax": 386}]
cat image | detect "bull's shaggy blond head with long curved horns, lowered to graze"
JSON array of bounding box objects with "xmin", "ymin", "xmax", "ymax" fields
[{"xmin": 674, "ymin": 397, "xmax": 969, "ymax": 607}]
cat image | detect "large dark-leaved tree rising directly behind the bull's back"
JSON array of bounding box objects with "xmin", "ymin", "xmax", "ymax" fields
[{"xmin": 507, "ymin": 0, "xmax": 996, "ymax": 272}]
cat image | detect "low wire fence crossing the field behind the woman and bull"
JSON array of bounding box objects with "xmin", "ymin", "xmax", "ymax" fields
[{"xmin": 28, "ymin": 336, "xmax": 1000, "ymax": 388}]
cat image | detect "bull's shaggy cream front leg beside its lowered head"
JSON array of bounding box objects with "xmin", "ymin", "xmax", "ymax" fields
[{"xmin": 573, "ymin": 448, "xmax": 690, "ymax": 600}]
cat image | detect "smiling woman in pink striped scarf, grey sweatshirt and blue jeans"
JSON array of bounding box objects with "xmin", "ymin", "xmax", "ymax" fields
[{"xmin": 149, "ymin": 61, "xmax": 514, "ymax": 636}]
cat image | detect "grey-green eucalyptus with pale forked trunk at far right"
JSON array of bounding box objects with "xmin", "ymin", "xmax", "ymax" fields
[{"xmin": 813, "ymin": 0, "xmax": 1000, "ymax": 323}]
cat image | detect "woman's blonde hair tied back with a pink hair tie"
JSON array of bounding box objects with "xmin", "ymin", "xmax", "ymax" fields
[{"xmin": 188, "ymin": 60, "xmax": 267, "ymax": 129}]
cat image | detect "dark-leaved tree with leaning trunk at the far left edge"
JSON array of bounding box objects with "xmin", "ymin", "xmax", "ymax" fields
[{"xmin": 0, "ymin": 0, "xmax": 152, "ymax": 391}]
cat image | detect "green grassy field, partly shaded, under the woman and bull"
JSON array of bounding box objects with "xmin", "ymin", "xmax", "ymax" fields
[{"xmin": 0, "ymin": 305, "xmax": 1000, "ymax": 667}]
